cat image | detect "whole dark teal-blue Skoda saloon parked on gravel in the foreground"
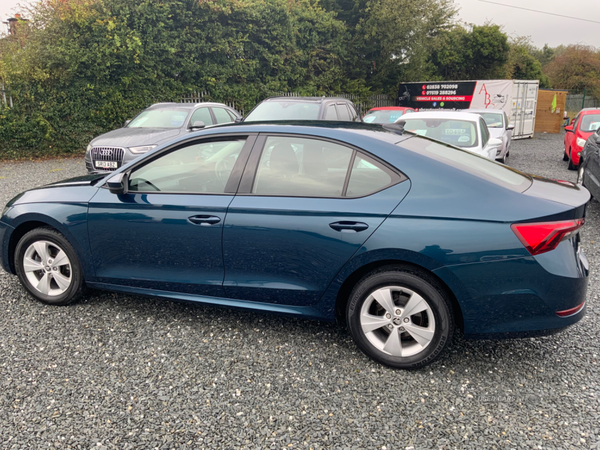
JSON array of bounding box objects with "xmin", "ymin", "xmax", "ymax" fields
[{"xmin": 0, "ymin": 122, "xmax": 590, "ymax": 369}]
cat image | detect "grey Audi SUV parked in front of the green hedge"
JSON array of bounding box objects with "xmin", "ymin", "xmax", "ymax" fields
[{"xmin": 85, "ymin": 102, "xmax": 242, "ymax": 173}]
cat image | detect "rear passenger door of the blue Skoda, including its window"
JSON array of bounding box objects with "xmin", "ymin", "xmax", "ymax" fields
[{"xmin": 223, "ymin": 134, "xmax": 409, "ymax": 306}]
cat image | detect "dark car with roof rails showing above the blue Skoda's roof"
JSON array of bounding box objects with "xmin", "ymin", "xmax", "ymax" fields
[{"xmin": 243, "ymin": 97, "xmax": 362, "ymax": 122}]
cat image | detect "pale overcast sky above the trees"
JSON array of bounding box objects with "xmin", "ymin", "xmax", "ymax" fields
[{"xmin": 0, "ymin": 0, "xmax": 600, "ymax": 47}]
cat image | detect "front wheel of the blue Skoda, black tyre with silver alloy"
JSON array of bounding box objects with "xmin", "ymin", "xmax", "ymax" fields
[{"xmin": 15, "ymin": 228, "xmax": 85, "ymax": 305}]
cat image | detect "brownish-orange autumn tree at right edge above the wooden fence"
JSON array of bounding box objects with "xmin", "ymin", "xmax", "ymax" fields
[{"xmin": 544, "ymin": 45, "xmax": 600, "ymax": 98}]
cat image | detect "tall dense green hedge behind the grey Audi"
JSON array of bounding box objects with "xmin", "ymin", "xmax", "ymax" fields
[{"xmin": 0, "ymin": 0, "xmax": 346, "ymax": 157}]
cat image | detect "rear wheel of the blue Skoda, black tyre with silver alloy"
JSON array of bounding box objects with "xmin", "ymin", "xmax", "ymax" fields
[{"xmin": 346, "ymin": 267, "xmax": 454, "ymax": 369}]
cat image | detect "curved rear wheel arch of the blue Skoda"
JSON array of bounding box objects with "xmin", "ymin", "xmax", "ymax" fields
[{"xmin": 335, "ymin": 258, "xmax": 464, "ymax": 331}]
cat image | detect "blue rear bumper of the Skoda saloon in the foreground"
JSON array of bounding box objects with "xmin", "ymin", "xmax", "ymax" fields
[{"xmin": 436, "ymin": 241, "xmax": 588, "ymax": 338}]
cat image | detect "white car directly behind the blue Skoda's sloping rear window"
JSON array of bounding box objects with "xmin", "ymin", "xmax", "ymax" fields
[{"xmin": 396, "ymin": 110, "xmax": 502, "ymax": 160}]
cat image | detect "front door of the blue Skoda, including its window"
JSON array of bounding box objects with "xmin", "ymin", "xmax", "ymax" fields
[{"xmin": 88, "ymin": 136, "xmax": 252, "ymax": 296}]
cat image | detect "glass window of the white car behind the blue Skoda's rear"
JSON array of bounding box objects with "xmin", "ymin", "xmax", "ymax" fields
[{"xmin": 402, "ymin": 115, "xmax": 478, "ymax": 148}]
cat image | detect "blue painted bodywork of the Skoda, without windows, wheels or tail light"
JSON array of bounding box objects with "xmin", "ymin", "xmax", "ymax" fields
[{"xmin": 0, "ymin": 122, "xmax": 590, "ymax": 336}]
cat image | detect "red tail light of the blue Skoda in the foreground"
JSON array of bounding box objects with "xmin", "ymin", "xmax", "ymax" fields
[{"xmin": 510, "ymin": 219, "xmax": 583, "ymax": 255}]
